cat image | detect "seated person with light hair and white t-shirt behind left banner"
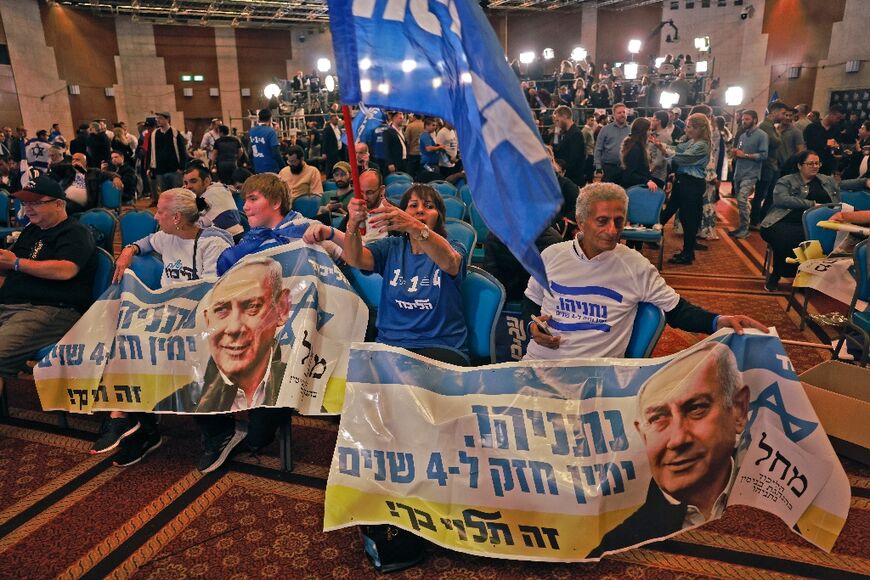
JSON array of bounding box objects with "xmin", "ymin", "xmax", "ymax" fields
[{"xmin": 97, "ymin": 188, "xmax": 233, "ymax": 467}]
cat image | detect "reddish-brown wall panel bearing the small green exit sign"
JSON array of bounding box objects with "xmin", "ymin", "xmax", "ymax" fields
[{"xmin": 154, "ymin": 25, "xmax": 221, "ymax": 137}]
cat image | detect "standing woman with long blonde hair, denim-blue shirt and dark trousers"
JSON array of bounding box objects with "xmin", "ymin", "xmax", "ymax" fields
[{"xmin": 657, "ymin": 113, "xmax": 712, "ymax": 264}]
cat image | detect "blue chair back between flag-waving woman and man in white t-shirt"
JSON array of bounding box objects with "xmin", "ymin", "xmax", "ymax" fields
[{"xmin": 462, "ymin": 266, "xmax": 506, "ymax": 365}]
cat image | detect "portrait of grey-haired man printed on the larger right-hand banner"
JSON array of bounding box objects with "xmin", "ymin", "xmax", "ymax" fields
[{"xmin": 589, "ymin": 342, "xmax": 749, "ymax": 558}]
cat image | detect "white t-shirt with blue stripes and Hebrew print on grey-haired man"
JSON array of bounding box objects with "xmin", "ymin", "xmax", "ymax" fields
[{"xmin": 524, "ymin": 239, "xmax": 680, "ymax": 360}]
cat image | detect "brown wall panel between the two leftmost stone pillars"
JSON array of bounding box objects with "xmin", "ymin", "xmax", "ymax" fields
[{"xmin": 39, "ymin": 4, "xmax": 118, "ymax": 126}]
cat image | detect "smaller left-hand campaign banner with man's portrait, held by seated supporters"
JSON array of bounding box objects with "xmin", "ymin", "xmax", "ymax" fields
[{"xmin": 33, "ymin": 241, "xmax": 368, "ymax": 414}]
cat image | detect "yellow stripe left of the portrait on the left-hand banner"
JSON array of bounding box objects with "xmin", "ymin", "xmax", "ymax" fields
[{"xmin": 37, "ymin": 373, "xmax": 194, "ymax": 412}]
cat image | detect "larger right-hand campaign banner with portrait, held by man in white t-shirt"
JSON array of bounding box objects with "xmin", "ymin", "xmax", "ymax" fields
[{"xmin": 324, "ymin": 330, "xmax": 850, "ymax": 562}]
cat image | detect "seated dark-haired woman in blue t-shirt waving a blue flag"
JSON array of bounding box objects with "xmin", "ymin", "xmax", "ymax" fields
[{"xmin": 305, "ymin": 184, "xmax": 469, "ymax": 572}]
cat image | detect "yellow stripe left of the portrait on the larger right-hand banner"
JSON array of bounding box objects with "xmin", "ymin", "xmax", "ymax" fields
[{"xmin": 323, "ymin": 485, "xmax": 639, "ymax": 561}]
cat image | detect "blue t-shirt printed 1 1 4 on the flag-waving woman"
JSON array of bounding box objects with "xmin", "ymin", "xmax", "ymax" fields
[{"xmin": 366, "ymin": 236, "xmax": 468, "ymax": 353}]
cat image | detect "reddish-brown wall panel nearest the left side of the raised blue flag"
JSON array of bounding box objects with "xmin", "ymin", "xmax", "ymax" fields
[{"xmin": 236, "ymin": 28, "xmax": 292, "ymax": 112}]
